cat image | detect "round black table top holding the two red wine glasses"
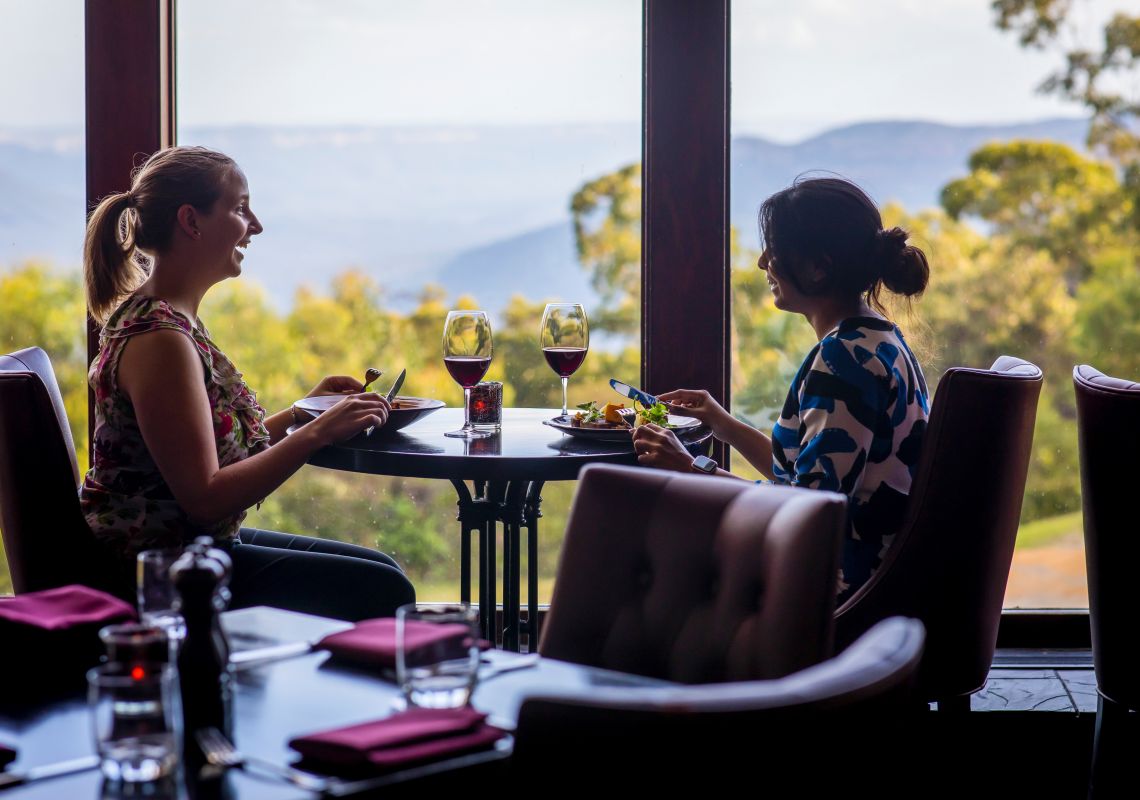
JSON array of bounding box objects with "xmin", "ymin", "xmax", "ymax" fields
[{"xmin": 309, "ymin": 408, "xmax": 711, "ymax": 481}]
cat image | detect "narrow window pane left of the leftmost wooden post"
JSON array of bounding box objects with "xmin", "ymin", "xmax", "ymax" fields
[{"xmin": 0, "ymin": 0, "xmax": 88, "ymax": 594}]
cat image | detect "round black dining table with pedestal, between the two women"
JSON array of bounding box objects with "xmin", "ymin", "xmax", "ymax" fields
[{"xmin": 309, "ymin": 408, "xmax": 711, "ymax": 651}]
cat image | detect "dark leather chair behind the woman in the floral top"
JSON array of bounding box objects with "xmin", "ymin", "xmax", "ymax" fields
[{"xmin": 0, "ymin": 348, "xmax": 128, "ymax": 601}]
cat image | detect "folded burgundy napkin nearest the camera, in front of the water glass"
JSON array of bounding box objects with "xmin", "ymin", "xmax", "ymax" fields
[{"xmin": 288, "ymin": 707, "xmax": 506, "ymax": 769}]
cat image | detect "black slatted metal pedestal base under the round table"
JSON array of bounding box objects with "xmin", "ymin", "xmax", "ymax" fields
[{"xmin": 451, "ymin": 479, "xmax": 544, "ymax": 652}]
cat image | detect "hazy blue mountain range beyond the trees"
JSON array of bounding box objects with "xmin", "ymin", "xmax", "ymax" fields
[{"xmin": 0, "ymin": 120, "xmax": 1088, "ymax": 312}]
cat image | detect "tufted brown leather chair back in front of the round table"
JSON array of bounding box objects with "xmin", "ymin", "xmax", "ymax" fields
[{"xmin": 538, "ymin": 465, "xmax": 847, "ymax": 683}]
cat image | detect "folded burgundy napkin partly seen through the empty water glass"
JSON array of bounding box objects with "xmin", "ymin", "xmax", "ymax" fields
[{"xmin": 317, "ymin": 617, "xmax": 490, "ymax": 669}]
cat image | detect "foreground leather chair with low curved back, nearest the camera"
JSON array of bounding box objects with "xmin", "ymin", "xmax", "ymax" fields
[{"xmin": 512, "ymin": 618, "xmax": 925, "ymax": 797}]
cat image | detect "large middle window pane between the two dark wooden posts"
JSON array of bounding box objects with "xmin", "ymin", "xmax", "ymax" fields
[{"xmin": 177, "ymin": 0, "xmax": 641, "ymax": 601}]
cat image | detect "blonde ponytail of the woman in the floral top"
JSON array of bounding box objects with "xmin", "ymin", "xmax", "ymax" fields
[{"xmin": 83, "ymin": 191, "xmax": 146, "ymax": 325}]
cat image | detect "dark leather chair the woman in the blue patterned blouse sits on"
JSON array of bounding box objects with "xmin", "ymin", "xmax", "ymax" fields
[{"xmin": 836, "ymin": 356, "xmax": 1042, "ymax": 710}]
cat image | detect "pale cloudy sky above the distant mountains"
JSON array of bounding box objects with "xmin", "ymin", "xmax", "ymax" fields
[{"xmin": 0, "ymin": 0, "xmax": 1140, "ymax": 141}]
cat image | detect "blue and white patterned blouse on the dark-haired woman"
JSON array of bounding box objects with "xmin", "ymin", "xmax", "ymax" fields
[{"xmin": 772, "ymin": 317, "xmax": 930, "ymax": 603}]
